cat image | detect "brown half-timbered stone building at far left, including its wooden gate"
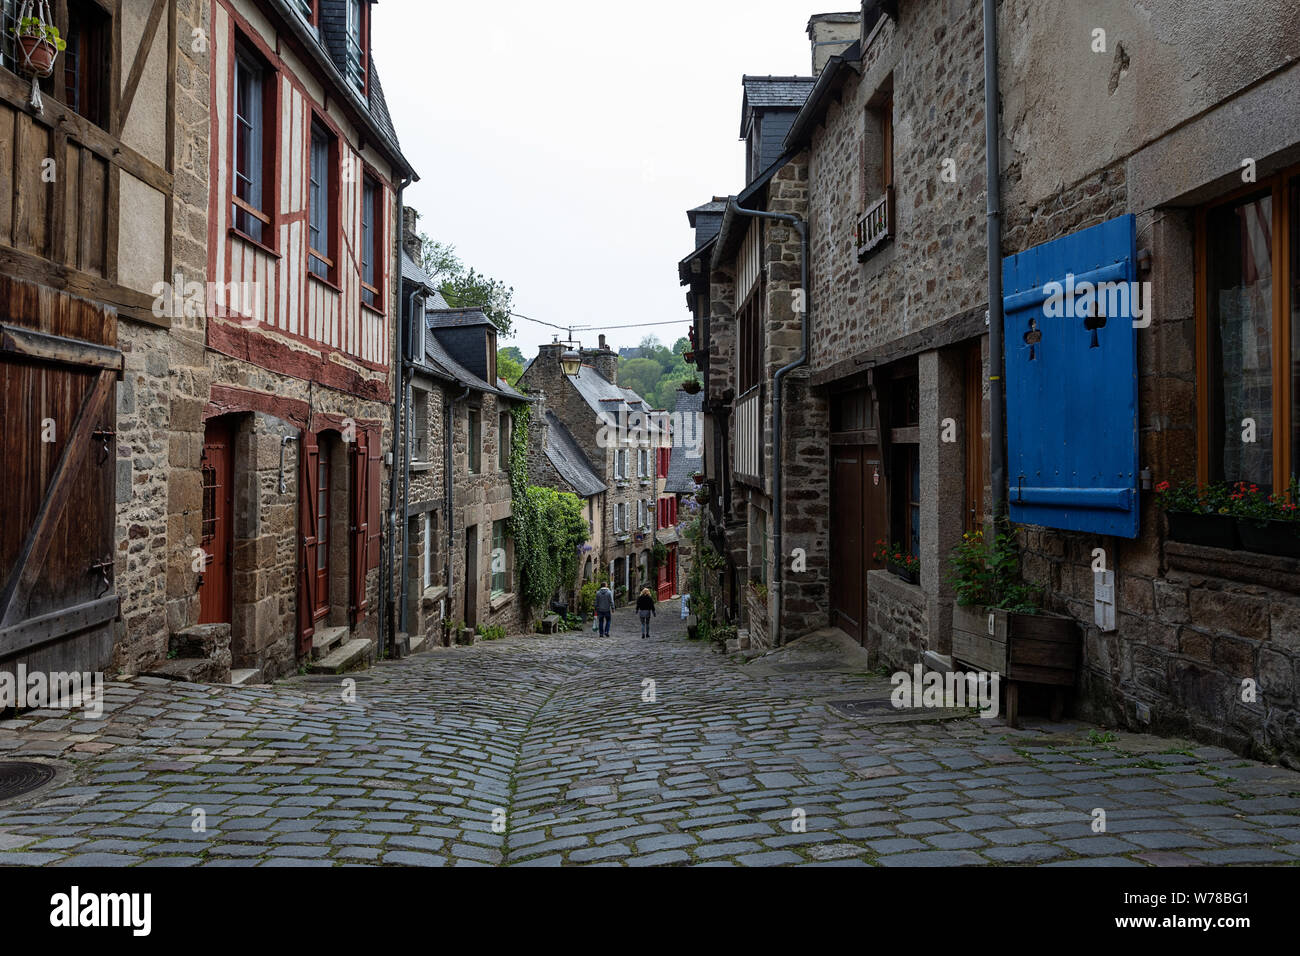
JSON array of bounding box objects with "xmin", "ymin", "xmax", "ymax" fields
[{"xmin": 0, "ymin": 0, "xmax": 189, "ymax": 674}]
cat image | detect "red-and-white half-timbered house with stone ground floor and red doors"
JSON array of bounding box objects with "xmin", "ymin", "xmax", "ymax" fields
[{"xmin": 118, "ymin": 0, "xmax": 413, "ymax": 680}]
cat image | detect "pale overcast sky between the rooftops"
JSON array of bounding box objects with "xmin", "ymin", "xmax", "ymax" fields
[{"xmin": 373, "ymin": 0, "xmax": 837, "ymax": 356}]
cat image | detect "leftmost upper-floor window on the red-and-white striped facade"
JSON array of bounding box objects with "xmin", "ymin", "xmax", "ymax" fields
[{"xmin": 231, "ymin": 43, "xmax": 274, "ymax": 243}]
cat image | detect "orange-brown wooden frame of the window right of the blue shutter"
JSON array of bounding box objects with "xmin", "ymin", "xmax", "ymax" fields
[{"xmin": 1195, "ymin": 165, "xmax": 1300, "ymax": 493}]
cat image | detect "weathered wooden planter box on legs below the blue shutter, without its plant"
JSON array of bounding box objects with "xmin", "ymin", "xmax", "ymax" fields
[{"xmin": 953, "ymin": 605, "xmax": 1080, "ymax": 727}]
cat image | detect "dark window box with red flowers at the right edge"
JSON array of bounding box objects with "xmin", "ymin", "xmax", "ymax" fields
[{"xmin": 1156, "ymin": 479, "xmax": 1300, "ymax": 558}]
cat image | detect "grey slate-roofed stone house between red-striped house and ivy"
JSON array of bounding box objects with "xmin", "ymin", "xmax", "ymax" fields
[{"xmin": 398, "ymin": 235, "xmax": 527, "ymax": 649}]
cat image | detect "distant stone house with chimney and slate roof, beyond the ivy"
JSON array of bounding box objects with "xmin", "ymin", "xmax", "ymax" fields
[{"xmin": 520, "ymin": 336, "xmax": 659, "ymax": 601}]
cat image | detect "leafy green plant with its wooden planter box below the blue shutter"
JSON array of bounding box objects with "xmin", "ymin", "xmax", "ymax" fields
[{"xmin": 949, "ymin": 528, "xmax": 1080, "ymax": 726}]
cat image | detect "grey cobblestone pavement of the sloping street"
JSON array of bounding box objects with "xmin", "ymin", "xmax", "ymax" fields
[{"xmin": 0, "ymin": 605, "xmax": 1300, "ymax": 866}]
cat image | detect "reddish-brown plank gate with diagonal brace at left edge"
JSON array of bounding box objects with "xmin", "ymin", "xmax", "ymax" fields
[{"xmin": 0, "ymin": 276, "xmax": 122, "ymax": 671}]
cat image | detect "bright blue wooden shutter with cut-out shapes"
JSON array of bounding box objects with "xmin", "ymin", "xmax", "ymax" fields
[{"xmin": 1002, "ymin": 216, "xmax": 1139, "ymax": 537}]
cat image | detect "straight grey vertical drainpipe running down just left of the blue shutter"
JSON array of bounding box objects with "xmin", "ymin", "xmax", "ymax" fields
[{"xmin": 984, "ymin": 0, "xmax": 1006, "ymax": 522}]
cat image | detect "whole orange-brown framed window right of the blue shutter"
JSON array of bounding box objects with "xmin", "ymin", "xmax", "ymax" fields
[{"xmin": 1196, "ymin": 170, "xmax": 1300, "ymax": 492}]
